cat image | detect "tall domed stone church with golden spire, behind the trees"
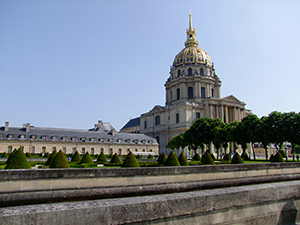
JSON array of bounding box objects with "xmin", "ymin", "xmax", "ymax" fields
[{"xmin": 121, "ymin": 14, "xmax": 251, "ymax": 155}]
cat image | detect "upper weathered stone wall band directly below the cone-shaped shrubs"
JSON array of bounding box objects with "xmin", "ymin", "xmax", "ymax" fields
[{"xmin": 0, "ymin": 162, "xmax": 300, "ymax": 182}]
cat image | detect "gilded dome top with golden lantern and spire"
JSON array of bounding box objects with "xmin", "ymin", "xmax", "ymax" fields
[{"xmin": 173, "ymin": 14, "xmax": 213, "ymax": 68}]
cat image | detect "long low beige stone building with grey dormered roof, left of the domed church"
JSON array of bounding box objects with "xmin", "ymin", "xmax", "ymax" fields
[{"xmin": 0, "ymin": 121, "xmax": 158, "ymax": 155}]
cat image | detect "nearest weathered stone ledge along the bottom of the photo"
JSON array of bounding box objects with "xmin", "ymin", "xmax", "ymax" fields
[{"xmin": 0, "ymin": 181, "xmax": 300, "ymax": 225}]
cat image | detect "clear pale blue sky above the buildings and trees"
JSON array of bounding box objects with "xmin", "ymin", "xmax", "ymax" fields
[{"xmin": 0, "ymin": 0, "xmax": 300, "ymax": 130}]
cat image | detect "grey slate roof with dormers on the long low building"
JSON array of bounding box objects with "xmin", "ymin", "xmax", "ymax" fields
[{"xmin": 0, "ymin": 127, "xmax": 157, "ymax": 144}]
